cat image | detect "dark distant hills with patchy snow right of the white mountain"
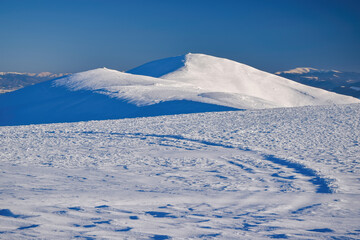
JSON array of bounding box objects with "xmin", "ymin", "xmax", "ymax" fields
[{"xmin": 275, "ymin": 68, "xmax": 360, "ymax": 98}]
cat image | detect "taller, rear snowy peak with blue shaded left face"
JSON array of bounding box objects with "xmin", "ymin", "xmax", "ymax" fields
[{"xmin": 129, "ymin": 54, "xmax": 358, "ymax": 108}]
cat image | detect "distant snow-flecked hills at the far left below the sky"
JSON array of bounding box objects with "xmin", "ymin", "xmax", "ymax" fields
[{"xmin": 0, "ymin": 72, "xmax": 68, "ymax": 94}]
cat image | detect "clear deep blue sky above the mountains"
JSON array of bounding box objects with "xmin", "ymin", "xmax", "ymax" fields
[{"xmin": 0, "ymin": 0, "xmax": 360, "ymax": 72}]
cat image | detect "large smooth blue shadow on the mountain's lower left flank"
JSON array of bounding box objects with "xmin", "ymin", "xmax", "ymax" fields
[{"xmin": 0, "ymin": 80, "xmax": 239, "ymax": 126}]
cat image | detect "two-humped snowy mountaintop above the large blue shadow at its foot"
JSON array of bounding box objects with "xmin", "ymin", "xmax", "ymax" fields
[{"xmin": 55, "ymin": 53, "xmax": 359, "ymax": 109}]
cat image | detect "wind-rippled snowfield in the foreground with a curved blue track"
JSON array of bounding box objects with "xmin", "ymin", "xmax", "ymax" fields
[{"xmin": 0, "ymin": 104, "xmax": 360, "ymax": 239}]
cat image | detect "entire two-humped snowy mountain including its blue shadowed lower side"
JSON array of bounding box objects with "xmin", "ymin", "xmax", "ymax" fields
[{"xmin": 0, "ymin": 54, "xmax": 360, "ymax": 125}]
